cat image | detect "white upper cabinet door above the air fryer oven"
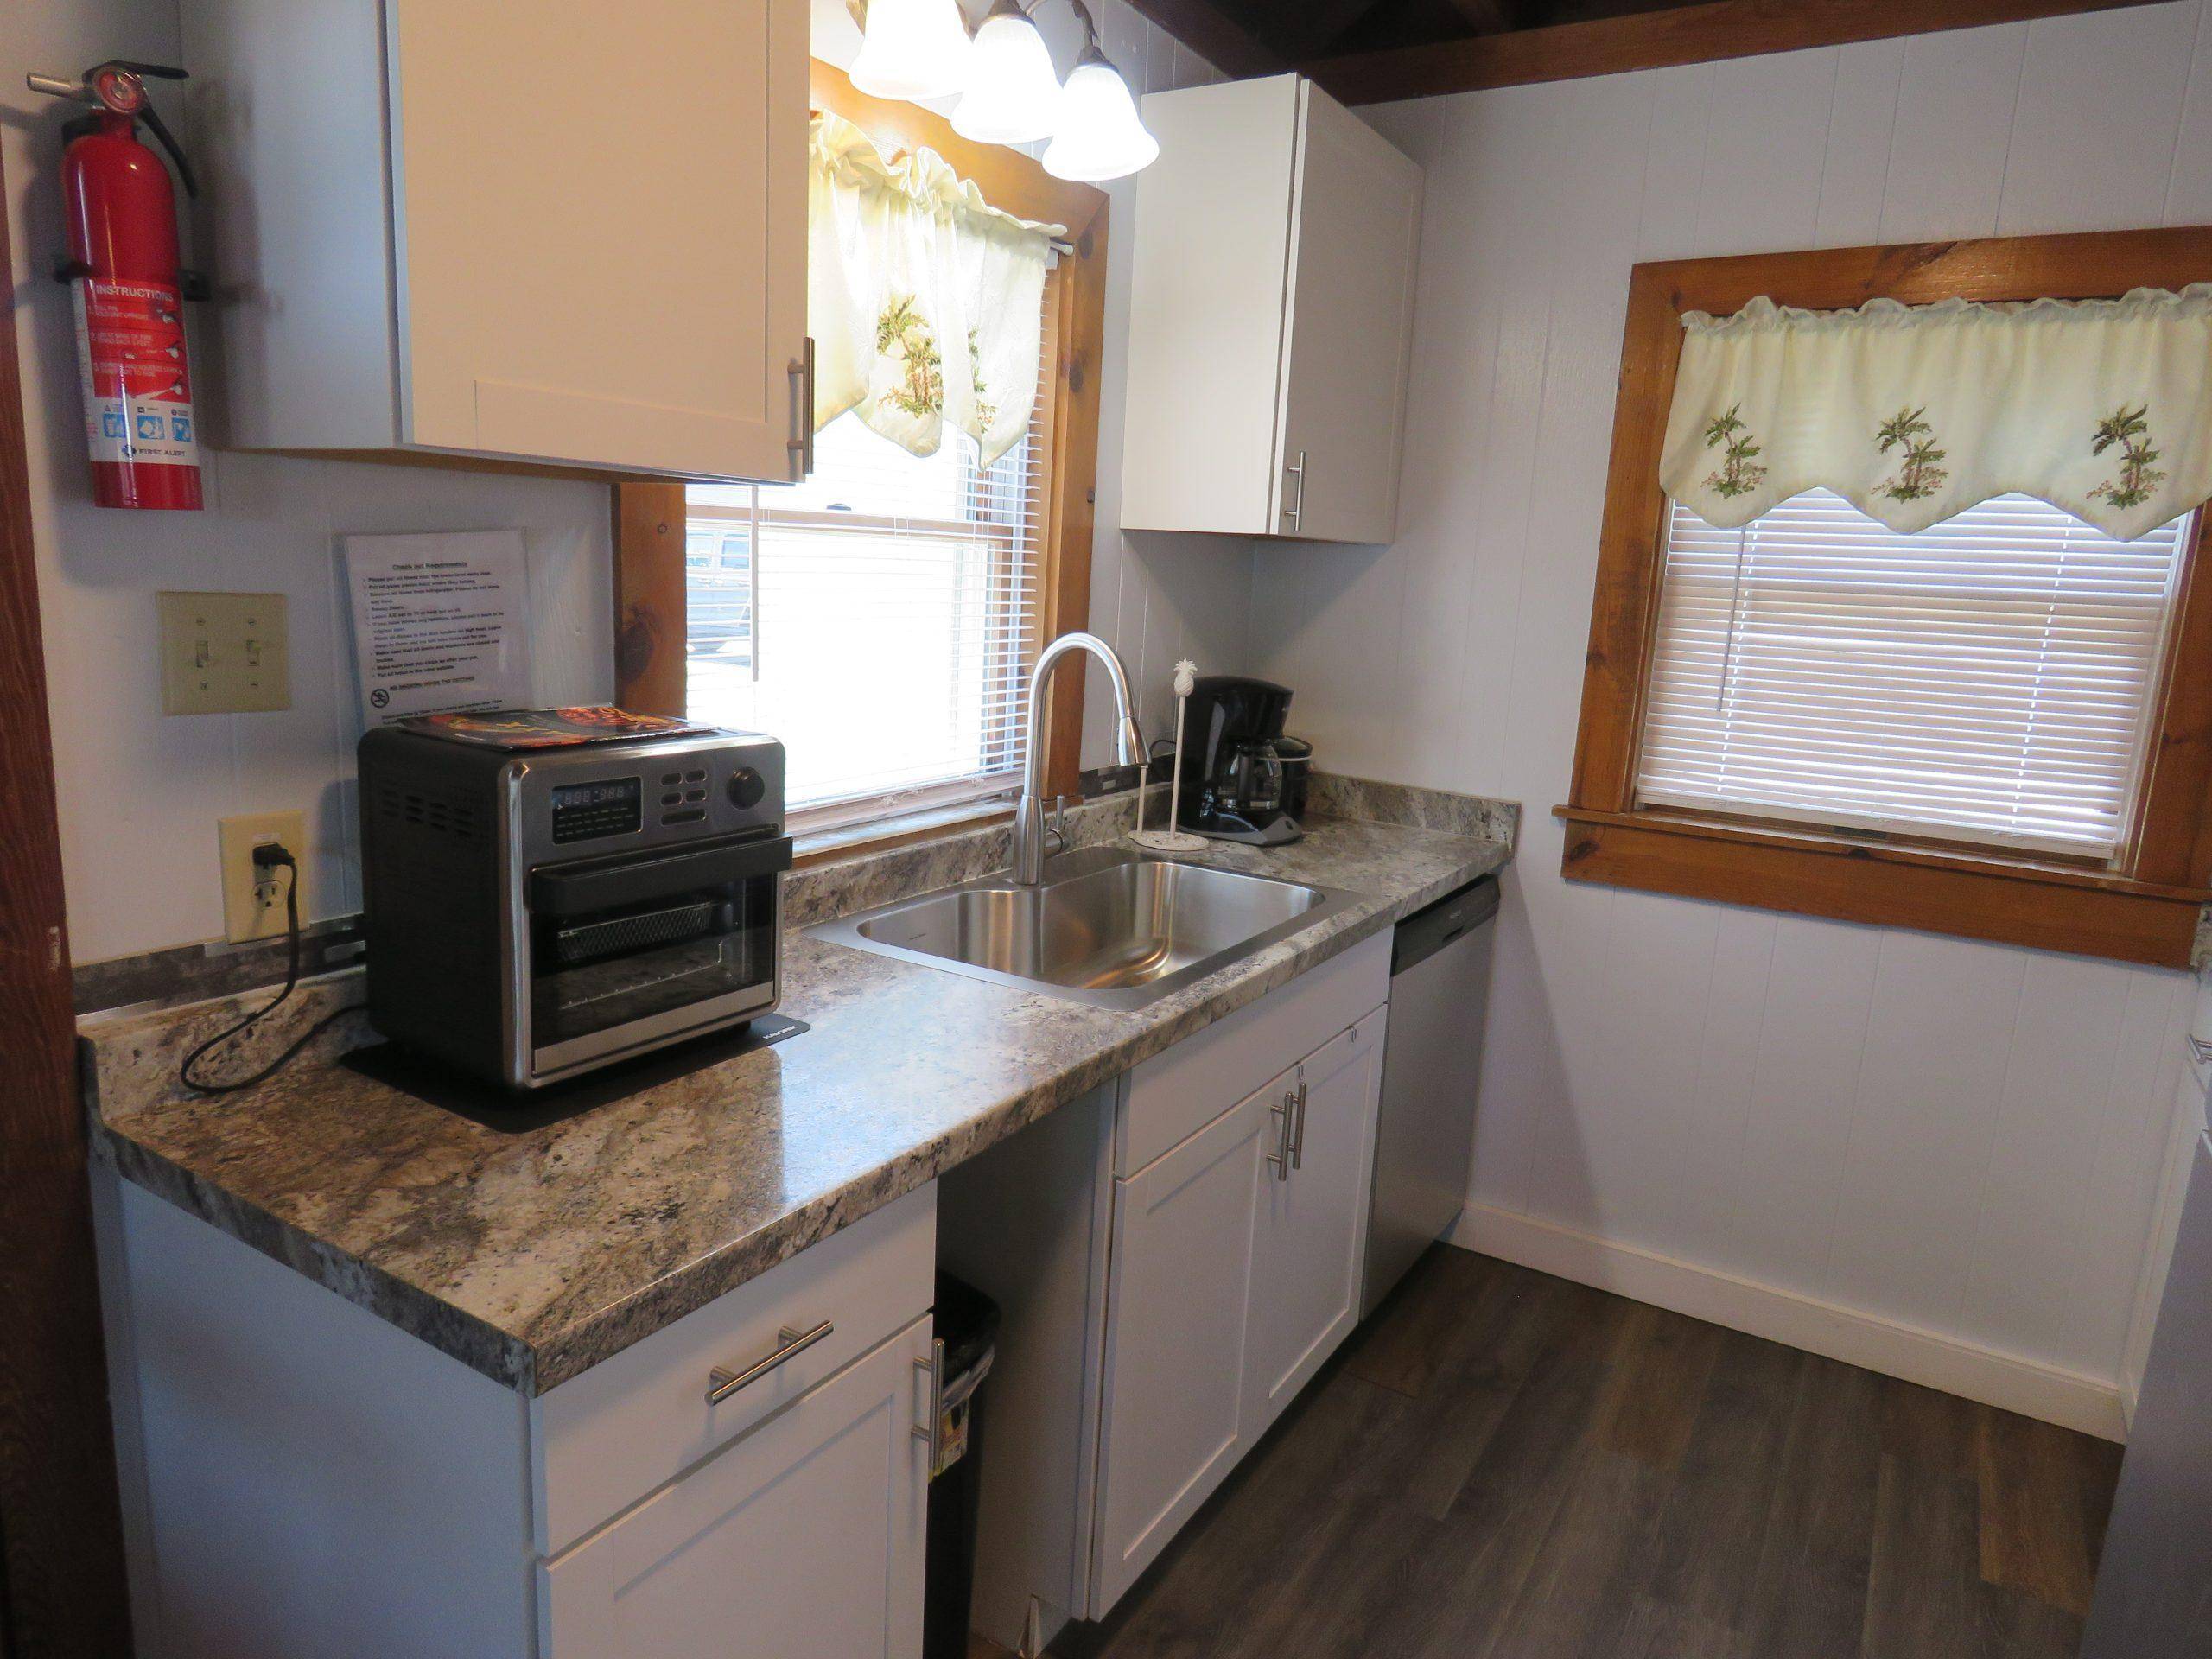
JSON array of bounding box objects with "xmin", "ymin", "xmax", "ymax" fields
[{"xmin": 387, "ymin": 0, "xmax": 807, "ymax": 478}]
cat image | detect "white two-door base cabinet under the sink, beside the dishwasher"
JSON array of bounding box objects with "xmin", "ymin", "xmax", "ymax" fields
[{"xmin": 1089, "ymin": 940, "xmax": 1389, "ymax": 1619}]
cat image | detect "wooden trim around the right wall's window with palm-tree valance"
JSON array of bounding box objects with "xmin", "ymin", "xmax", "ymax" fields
[{"xmin": 1555, "ymin": 226, "xmax": 2212, "ymax": 967}]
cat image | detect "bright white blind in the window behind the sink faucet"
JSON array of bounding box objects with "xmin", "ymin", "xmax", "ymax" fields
[{"xmin": 686, "ymin": 283, "xmax": 1058, "ymax": 827}]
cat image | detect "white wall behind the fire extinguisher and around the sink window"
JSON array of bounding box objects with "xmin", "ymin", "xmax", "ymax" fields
[{"xmin": 13, "ymin": 0, "xmax": 1252, "ymax": 963}]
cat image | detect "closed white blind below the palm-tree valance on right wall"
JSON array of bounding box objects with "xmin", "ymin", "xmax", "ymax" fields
[{"xmin": 1637, "ymin": 489, "xmax": 2190, "ymax": 858}]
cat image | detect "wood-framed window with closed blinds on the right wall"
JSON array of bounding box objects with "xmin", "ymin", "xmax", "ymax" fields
[{"xmin": 1555, "ymin": 230, "xmax": 2212, "ymax": 967}]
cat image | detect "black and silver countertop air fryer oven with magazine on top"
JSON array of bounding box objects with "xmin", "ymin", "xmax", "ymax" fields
[{"xmin": 360, "ymin": 726, "xmax": 791, "ymax": 1089}]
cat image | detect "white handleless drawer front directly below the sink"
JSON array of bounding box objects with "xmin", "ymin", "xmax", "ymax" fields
[{"xmin": 1113, "ymin": 931, "xmax": 1391, "ymax": 1174}]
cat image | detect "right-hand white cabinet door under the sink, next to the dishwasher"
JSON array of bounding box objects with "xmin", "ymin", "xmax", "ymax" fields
[{"xmin": 1243, "ymin": 1008, "xmax": 1385, "ymax": 1435}]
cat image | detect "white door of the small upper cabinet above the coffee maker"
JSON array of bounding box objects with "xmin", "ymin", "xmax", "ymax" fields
[{"xmin": 1274, "ymin": 84, "xmax": 1421, "ymax": 542}]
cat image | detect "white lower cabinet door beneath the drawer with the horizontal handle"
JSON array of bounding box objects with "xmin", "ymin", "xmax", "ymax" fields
[{"xmin": 542, "ymin": 1319, "xmax": 931, "ymax": 1659}]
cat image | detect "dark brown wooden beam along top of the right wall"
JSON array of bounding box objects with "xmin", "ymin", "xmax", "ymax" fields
[{"xmin": 1300, "ymin": 0, "xmax": 2152, "ymax": 104}]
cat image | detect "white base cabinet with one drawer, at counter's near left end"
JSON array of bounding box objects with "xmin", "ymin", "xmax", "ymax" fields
[{"xmin": 95, "ymin": 1170, "xmax": 938, "ymax": 1659}]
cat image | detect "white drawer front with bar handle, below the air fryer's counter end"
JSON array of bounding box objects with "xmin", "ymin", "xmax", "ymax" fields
[{"xmin": 536, "ymin": 1184, "xmax": 938, "ymax": 1555}]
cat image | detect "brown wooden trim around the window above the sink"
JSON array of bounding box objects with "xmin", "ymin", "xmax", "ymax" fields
[{"xmin": 613, "ymin": 60, "xmax": 1109, "ymax": 858}]
